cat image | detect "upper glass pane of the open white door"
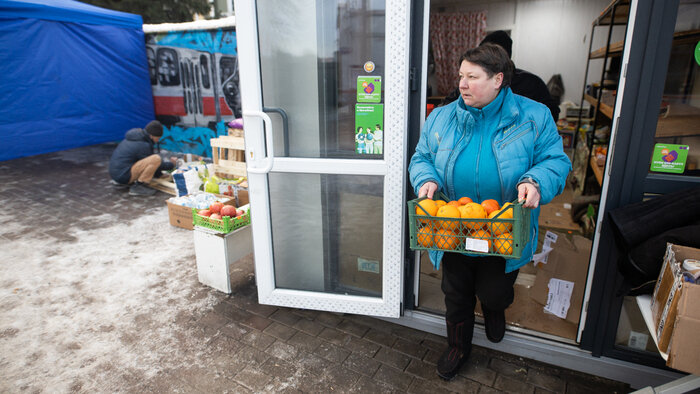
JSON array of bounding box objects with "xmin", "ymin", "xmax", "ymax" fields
[{"xmin": 257, "ymin": 0, "xmax": 385, "ymax": 159}]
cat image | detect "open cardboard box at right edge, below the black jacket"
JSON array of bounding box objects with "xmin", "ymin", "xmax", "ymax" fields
[{"xmin": 651, "ymin": 243, "xmax": 700, "ymax": 352}]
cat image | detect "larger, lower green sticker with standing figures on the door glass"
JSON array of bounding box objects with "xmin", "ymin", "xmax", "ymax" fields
[{"xmin": 355, "ymin": 104, "xmax": 384, "ymax": 155}]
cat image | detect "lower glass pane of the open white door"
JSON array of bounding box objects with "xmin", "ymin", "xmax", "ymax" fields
[{"xmin": 269, "ymin": 173, "xmax": 384, "ymax": 297}]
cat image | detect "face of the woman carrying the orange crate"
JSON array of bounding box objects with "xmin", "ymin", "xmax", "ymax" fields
[{"xmin": 459, "ymin": 60, "xmax": 503, "ymax": 108}]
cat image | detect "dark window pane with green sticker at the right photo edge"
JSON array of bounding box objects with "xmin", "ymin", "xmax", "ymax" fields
[{"xmin": 649, "ymin": 1, "xmax": 700, "ymax": 177}]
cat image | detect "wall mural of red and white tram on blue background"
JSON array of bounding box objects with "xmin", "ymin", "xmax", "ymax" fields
[{"xmin": 144, "ymin": 20, "xmax": 241, "ymax": 157}]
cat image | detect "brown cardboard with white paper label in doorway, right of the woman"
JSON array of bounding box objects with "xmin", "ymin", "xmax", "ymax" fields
[{"xmin": 530, "ymin": 233, "xmax": 591, "ymax": 324}]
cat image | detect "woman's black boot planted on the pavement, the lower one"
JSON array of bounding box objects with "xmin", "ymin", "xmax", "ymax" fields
[{"xmin": 437, "ymin": 321, "xmax": 474, "ymax": 380}]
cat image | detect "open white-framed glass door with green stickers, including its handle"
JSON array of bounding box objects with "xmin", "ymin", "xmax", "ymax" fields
[{"xmin": 235, "ymin": 0, "xmax": 409, "ymax": 317}]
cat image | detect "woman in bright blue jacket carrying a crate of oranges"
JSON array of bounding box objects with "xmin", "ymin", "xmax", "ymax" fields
[{"xmin": 409, "ymin": 44, "xmax": 571, "ymax": 380}]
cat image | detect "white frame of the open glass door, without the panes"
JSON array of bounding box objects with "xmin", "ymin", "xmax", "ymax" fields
[{"xmin": 235, "ymin": 0, "xmax": 410, "ymax": 317}]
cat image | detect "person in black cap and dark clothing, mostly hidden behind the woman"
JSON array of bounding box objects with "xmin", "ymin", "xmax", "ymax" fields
[{"xmin": 445, "ymin": 30, "xmax": 559, "ymax": 122}]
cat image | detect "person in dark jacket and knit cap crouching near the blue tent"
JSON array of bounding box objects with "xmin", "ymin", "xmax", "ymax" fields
[{"xmin": 109, "ymin": 120, "xmax": 177, "ymax": 196}]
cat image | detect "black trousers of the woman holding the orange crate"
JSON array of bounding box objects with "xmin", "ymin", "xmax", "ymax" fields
[{"xmin": 442, "ymin": 253, "xmax": 518, "ymax": 327}]
